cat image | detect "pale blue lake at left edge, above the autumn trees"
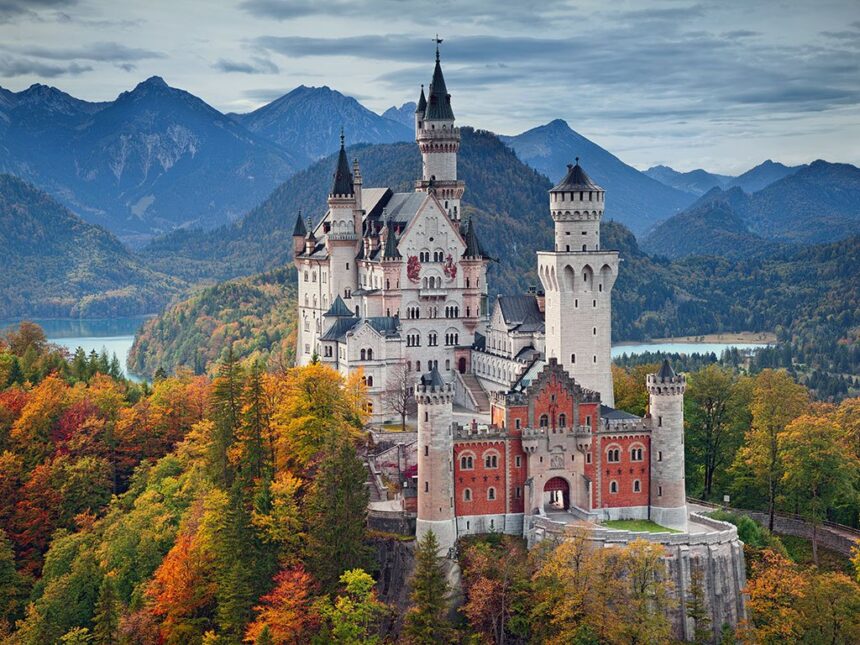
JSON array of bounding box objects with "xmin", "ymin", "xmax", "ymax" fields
[{"xmin": 0, "ymin": 316, "xmax": 147, "ymax": 381}]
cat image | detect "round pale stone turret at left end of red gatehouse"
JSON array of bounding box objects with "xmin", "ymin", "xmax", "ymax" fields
[{"xmin": 415, "ymin": 368, "xmax": 457, "ymax": 554}]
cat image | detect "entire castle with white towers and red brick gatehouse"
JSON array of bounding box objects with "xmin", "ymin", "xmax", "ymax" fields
[{"xmin": 293, "ymin": 47, "xmax": 687, "ymax": 546}]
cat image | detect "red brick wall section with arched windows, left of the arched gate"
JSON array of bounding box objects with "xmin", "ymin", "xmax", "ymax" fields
[{"xmin": 454, "ymin": 440, "xmax": 508, "ymax": 516}]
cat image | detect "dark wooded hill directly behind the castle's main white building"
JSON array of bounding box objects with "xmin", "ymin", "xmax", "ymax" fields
[{"xmin": 144, "ymin": 128, "xmax": 552, "ymax": 292}]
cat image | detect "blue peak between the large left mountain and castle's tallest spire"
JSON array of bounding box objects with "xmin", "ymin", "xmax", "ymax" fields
[{"xmin": 231, "ymin": 85, "xmax": 415, "ymax": 167}]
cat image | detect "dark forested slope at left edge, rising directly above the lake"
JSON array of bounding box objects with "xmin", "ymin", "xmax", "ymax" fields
[{"xmin": 0, "ymin": 174, "xmax": 182, "ymax": 318}]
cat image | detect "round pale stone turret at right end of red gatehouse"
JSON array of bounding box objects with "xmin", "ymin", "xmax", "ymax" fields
[{"xmin": 647, "ymin": 360, "xmax": 687, "ymax": 531}]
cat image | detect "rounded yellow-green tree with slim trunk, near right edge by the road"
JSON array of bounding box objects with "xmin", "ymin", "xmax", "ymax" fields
[{"xmin": 780, "ymin": 415, "xmax": 855, "ymax": 564}]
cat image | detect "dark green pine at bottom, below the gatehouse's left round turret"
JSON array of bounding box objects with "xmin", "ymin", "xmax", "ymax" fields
[{"xmin": 403, "ymin": 531, "xmax": 451, "ymax": 645}]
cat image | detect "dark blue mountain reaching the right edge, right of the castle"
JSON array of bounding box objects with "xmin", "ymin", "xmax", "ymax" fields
[{"xmin": 642, "ymin": 160, "xmax": 860, "ymax": 258}]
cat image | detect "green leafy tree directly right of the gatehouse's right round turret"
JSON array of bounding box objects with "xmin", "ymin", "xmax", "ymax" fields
[{"xmin": 684, "ymin": 365, "xmax": 752, "ymax": 499}]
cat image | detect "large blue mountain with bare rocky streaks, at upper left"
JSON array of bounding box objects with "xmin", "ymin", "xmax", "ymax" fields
[{"xmin": 0, "ymin": 77, "xmax": 297, "ymax": 241}]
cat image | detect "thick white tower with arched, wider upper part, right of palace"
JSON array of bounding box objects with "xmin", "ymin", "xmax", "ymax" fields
[{"xmin": 537, "ymin": 158, "xmax": 618, "ymax": 406}]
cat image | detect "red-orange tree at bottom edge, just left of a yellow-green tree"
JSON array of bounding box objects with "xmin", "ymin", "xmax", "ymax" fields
[{"xmin": 245, "ymin": 564, "xmax": 321, "ymax": 645}]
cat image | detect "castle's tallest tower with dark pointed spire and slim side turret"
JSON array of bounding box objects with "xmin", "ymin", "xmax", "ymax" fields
[{"xmin": 415, "ymin": 38, "xmax": 466, "ymax": 221}]
